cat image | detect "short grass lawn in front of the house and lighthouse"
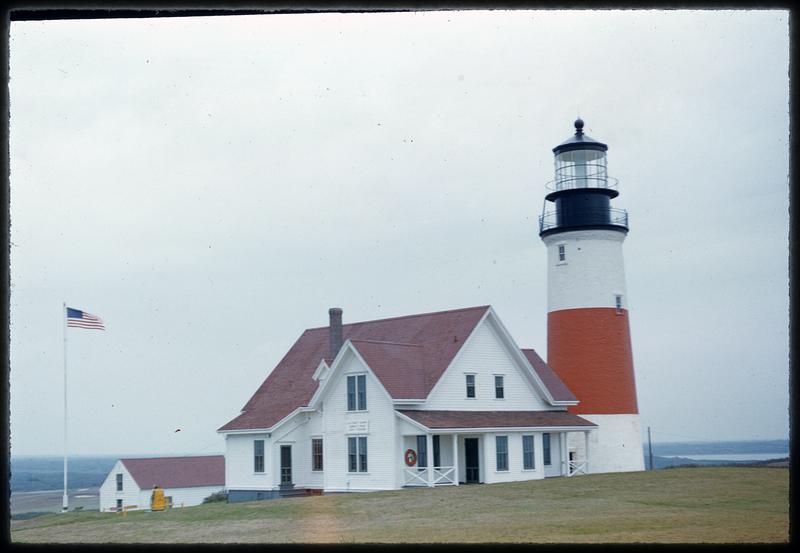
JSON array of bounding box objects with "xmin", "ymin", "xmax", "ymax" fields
[{"xmin": 11, "ymin": 467, "xmax": 789, "ymax": 543}]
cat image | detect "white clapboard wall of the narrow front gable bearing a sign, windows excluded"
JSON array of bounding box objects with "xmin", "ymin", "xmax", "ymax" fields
[{"xmin": 323, "ymin": 351, "xmax": 402, "ymax": 491}]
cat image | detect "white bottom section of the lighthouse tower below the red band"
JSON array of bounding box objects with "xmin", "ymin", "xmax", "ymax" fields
[{"xmin": 567, "ymin": 414, "xmax": 644, "ymax": 474}]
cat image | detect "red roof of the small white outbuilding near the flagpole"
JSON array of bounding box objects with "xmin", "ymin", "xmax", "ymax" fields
[{"xmin": 120, "ymin": 455, "xmax": 225, "ymax": 489}]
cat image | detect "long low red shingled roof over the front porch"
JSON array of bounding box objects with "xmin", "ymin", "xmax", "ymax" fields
[{"xmin": 397, "ymin": 410, "xmax": 597, "ymax": 429}]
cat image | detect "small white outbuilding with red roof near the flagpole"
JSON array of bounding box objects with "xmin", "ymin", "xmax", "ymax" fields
[{"xmin": 100, "ymin": 455, "xmax": 225, "ymax": 512}]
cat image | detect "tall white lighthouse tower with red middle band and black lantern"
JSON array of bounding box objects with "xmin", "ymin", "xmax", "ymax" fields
[{"xmin": 539, "ymin": 119, "xmax": 644, "ymax": 472}]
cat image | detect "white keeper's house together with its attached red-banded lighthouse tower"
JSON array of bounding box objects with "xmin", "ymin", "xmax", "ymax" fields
[{"xmin": 218, "ymin": 119, "xmax": 644, "ymax": 501}]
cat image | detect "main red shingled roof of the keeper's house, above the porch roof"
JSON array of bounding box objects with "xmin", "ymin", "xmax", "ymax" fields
[{"xmin": 219, "ymin": 305, "xmax": 575, "ymax": 432}]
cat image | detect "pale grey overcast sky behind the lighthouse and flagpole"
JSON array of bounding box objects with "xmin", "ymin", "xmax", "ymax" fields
[{"xmin": 10, "ymin": 11, "xmax": 789, "ymax": 455}]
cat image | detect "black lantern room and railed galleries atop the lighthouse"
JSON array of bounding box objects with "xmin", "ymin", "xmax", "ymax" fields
[{"xmin": 539, "ymin": 118, "xmax": 628, "ymax": 236}]
